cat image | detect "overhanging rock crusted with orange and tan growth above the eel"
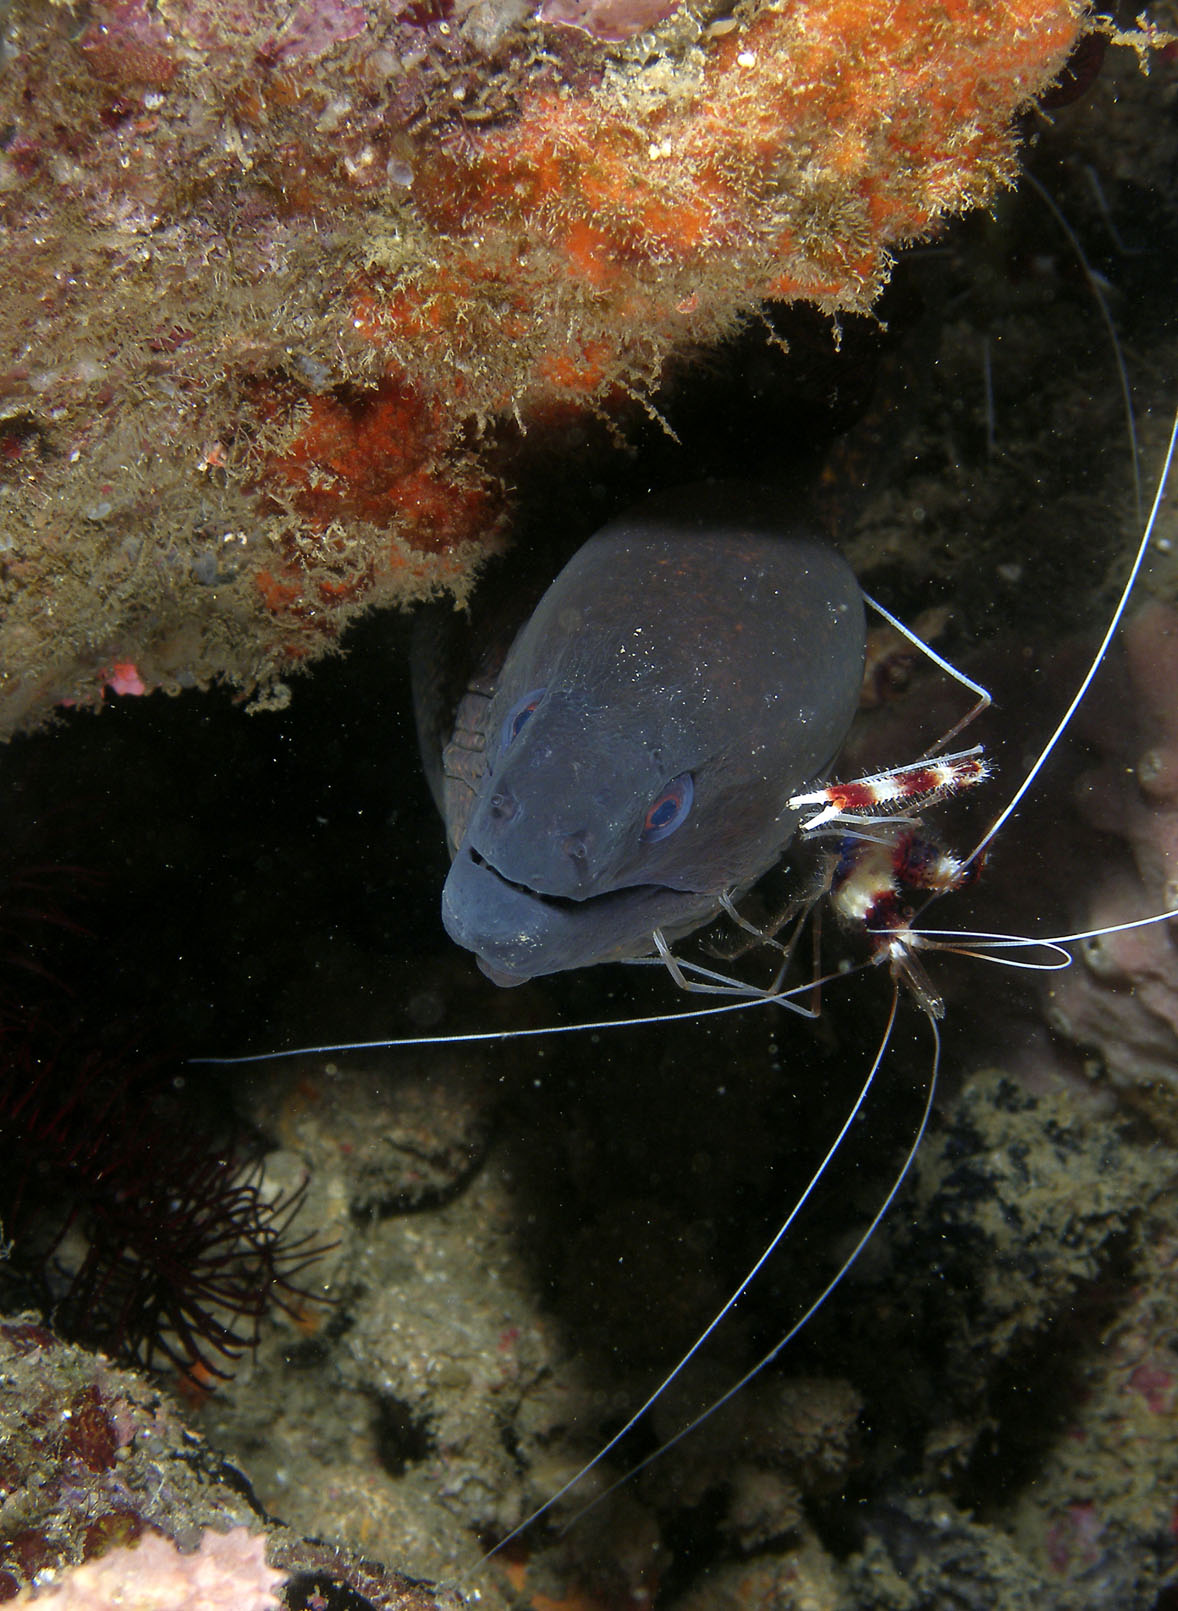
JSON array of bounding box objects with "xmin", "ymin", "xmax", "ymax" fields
[{"xmin": 0, "ymin": 0, "xmax": 1089, "ymax": 733}]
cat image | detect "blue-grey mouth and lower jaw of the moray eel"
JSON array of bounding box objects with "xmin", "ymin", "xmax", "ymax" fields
[{"xmin": 442, "ymin": 844, "xmax": 719, "ymax": 984}]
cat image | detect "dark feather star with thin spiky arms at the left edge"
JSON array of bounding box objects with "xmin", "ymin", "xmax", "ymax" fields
[{"xmin": 0, "ymin": 1025, "xmax": 327, "ymax": 1376}]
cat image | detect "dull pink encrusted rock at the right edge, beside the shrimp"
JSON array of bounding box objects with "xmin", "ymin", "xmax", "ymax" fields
[{"xmin": 1047, "ymin": 603, "xmax": 1178, "ymax": 1124}]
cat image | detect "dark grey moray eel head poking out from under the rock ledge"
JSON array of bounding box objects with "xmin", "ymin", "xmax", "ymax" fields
[{"xmin": 435, "ymin": 483, "xmax": 865, "ymax": 984}]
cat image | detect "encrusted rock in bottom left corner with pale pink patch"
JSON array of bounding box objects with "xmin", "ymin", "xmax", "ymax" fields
[{"xmin": 0, "ymin": 1316, "xmax": 470, "ymax": 1611}]
